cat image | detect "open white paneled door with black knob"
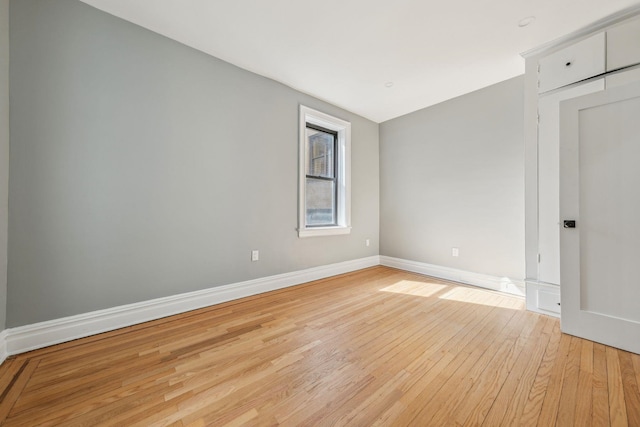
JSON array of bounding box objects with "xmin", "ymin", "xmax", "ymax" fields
[{"xmin": 560, "ymin": 83, "xmax": 640, "ymax": 353}]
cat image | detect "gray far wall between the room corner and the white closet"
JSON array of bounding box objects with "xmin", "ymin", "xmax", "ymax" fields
[{"xmin": 380, "ymin": 76, "xmax": 525, "ymax": 279}]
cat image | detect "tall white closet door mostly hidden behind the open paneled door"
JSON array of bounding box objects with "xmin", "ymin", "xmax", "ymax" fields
[{"xmin": 538, "ymin": 79, "xmax": 604, "ymax": 285}]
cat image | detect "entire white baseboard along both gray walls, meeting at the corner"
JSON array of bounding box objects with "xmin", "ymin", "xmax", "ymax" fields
[{"xmin": 0, "ymin": 255, "xmax": 525, "ymax": 363}]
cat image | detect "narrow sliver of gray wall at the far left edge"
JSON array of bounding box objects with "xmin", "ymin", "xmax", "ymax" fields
[{"xmin": 0, "ymin": 0, "xmax": 9, "ymax": 331}]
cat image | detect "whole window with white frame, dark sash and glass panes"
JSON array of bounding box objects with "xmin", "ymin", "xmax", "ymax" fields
[{"xmin": 298, "ymin": 105, "xmax": 351, "ymax": 237}]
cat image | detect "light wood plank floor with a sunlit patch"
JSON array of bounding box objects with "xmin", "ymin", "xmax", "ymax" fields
[{"xmin": 0, "ymin": 267, "xmax": 640, "ymax": 426}]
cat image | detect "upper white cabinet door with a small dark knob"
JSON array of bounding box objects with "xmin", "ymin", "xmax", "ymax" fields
[{"xmin": 538, "ymin": 33, "xmax": 605, "ymax": 93}]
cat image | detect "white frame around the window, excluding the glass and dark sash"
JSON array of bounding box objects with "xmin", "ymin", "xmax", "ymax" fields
[{"xmin": 298, "ymin": 105, "xmax": 351, "ymax": 237}]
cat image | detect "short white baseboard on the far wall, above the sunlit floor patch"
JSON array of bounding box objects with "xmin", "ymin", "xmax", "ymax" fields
[{"xmin": 380, "ymin": 256, "xmax": 525, "ymax": 297}]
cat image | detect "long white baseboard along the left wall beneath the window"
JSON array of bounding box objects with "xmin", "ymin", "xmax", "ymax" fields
[{"xmin": 0, "ymin": 255, "xmax": 380, "ymax": 357}]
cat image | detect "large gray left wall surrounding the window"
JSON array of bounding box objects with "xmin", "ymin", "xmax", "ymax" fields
[{"xmin": 7, "ymin": 0, "xmax": 379, "ymax": 327}]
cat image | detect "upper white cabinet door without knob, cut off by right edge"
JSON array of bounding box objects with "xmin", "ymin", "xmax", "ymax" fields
[{"xmin": 607, "ymin": 19, "xmax": 640, "ymax": 71}]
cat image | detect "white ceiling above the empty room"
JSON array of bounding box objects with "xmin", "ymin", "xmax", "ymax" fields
[{"xmin": 82, "ymin": 0, "xmax": 638, "ymax": 122}]
